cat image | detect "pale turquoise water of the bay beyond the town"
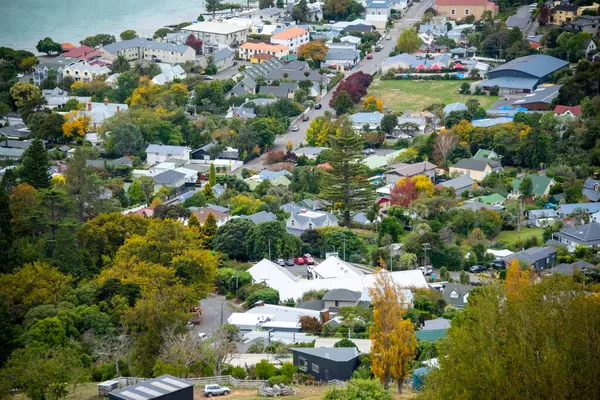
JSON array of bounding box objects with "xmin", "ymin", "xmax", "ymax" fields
[{"xmin": 0, "ymin": 0, "xmax": 204, "ymax": 52}]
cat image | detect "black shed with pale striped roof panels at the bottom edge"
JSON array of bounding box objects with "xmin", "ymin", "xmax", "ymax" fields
[{"xmin": 108, "ymin": 375, "xmax": 194, "ymax": 400}]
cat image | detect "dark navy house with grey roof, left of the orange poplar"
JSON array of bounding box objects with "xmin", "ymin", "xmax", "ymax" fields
[{"xmin": 290, "ymin": 347, "xmax": 360, "ymax": 382}]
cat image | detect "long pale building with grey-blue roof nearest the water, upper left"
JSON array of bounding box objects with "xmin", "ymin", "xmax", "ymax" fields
[{"xmin": 101, "ymin": 38, "xmax": 196, "ymax": 64}]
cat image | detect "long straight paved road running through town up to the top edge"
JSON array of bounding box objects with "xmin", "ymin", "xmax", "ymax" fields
[{"xmin": 244, "ymin": 0, "xmax": 433, "ymax": 171}]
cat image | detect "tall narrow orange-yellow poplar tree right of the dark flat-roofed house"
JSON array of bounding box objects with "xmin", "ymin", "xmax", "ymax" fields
[{"xmin": 369, "ymin": 260, "xmax": 417, "ymax": 393}]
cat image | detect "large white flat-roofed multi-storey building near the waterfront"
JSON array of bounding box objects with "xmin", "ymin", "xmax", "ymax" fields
[{"xmin": 181, "ymin": 21, "xmax": 249, "ymax": 54}]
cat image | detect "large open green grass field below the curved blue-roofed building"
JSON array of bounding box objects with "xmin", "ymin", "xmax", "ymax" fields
[{"xmin": 368, "ymin": 79, "xmax": 498, "ymax": 112}]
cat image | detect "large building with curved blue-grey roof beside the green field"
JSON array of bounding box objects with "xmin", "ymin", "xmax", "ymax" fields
[{"xmin": 479, "ymin": 54, "xmax": 569, "ymax": 94}]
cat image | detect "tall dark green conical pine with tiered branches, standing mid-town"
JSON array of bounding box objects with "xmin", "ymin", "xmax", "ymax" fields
[{"xmin": 320, "ymin": 116, "xmax": 375, "ymax": 227}]
